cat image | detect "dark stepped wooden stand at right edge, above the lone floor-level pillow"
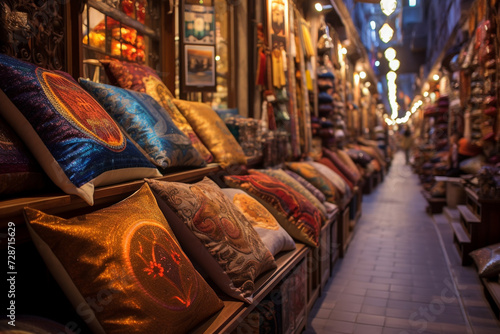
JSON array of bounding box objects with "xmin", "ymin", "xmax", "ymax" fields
[{"xmin": 451, "ymin": 187, "xmax": 500, "ymax": 265}]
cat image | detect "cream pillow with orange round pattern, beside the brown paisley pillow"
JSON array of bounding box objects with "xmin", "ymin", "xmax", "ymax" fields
[{"xmin": 222, "ymin": 188, "xmax": 296, "ymax": 256}]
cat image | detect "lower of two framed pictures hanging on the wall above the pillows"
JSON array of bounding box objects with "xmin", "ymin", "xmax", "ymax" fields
[{"xmin": 184, "ymin": 44, "xmax": 215, "ymax": 91}]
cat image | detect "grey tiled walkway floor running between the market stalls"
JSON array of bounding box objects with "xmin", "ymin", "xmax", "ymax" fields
[{"xmin": 304, "ymin": 152, "xmax": 500, "ymax": 334}]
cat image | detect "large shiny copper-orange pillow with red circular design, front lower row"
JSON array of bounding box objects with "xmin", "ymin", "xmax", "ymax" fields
[{"xmin": 25, "ymin": 184, "xmax": 223, "ymax": 333}]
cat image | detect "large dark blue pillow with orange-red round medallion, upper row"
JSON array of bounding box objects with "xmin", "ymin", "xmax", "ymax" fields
[{"xmin": 0, "ymin": 55, "xmax": 161, "ymax": 205}]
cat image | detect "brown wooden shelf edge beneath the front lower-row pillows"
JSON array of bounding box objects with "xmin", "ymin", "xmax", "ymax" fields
[{"xmin": 193, "ymin": 244, "xmax": 309, "ymax": 333}]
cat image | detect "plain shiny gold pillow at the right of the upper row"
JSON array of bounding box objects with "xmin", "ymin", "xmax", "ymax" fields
[{"xmin": 174, "ymin": 100, "xmax": 247, "ymax": 167}]
